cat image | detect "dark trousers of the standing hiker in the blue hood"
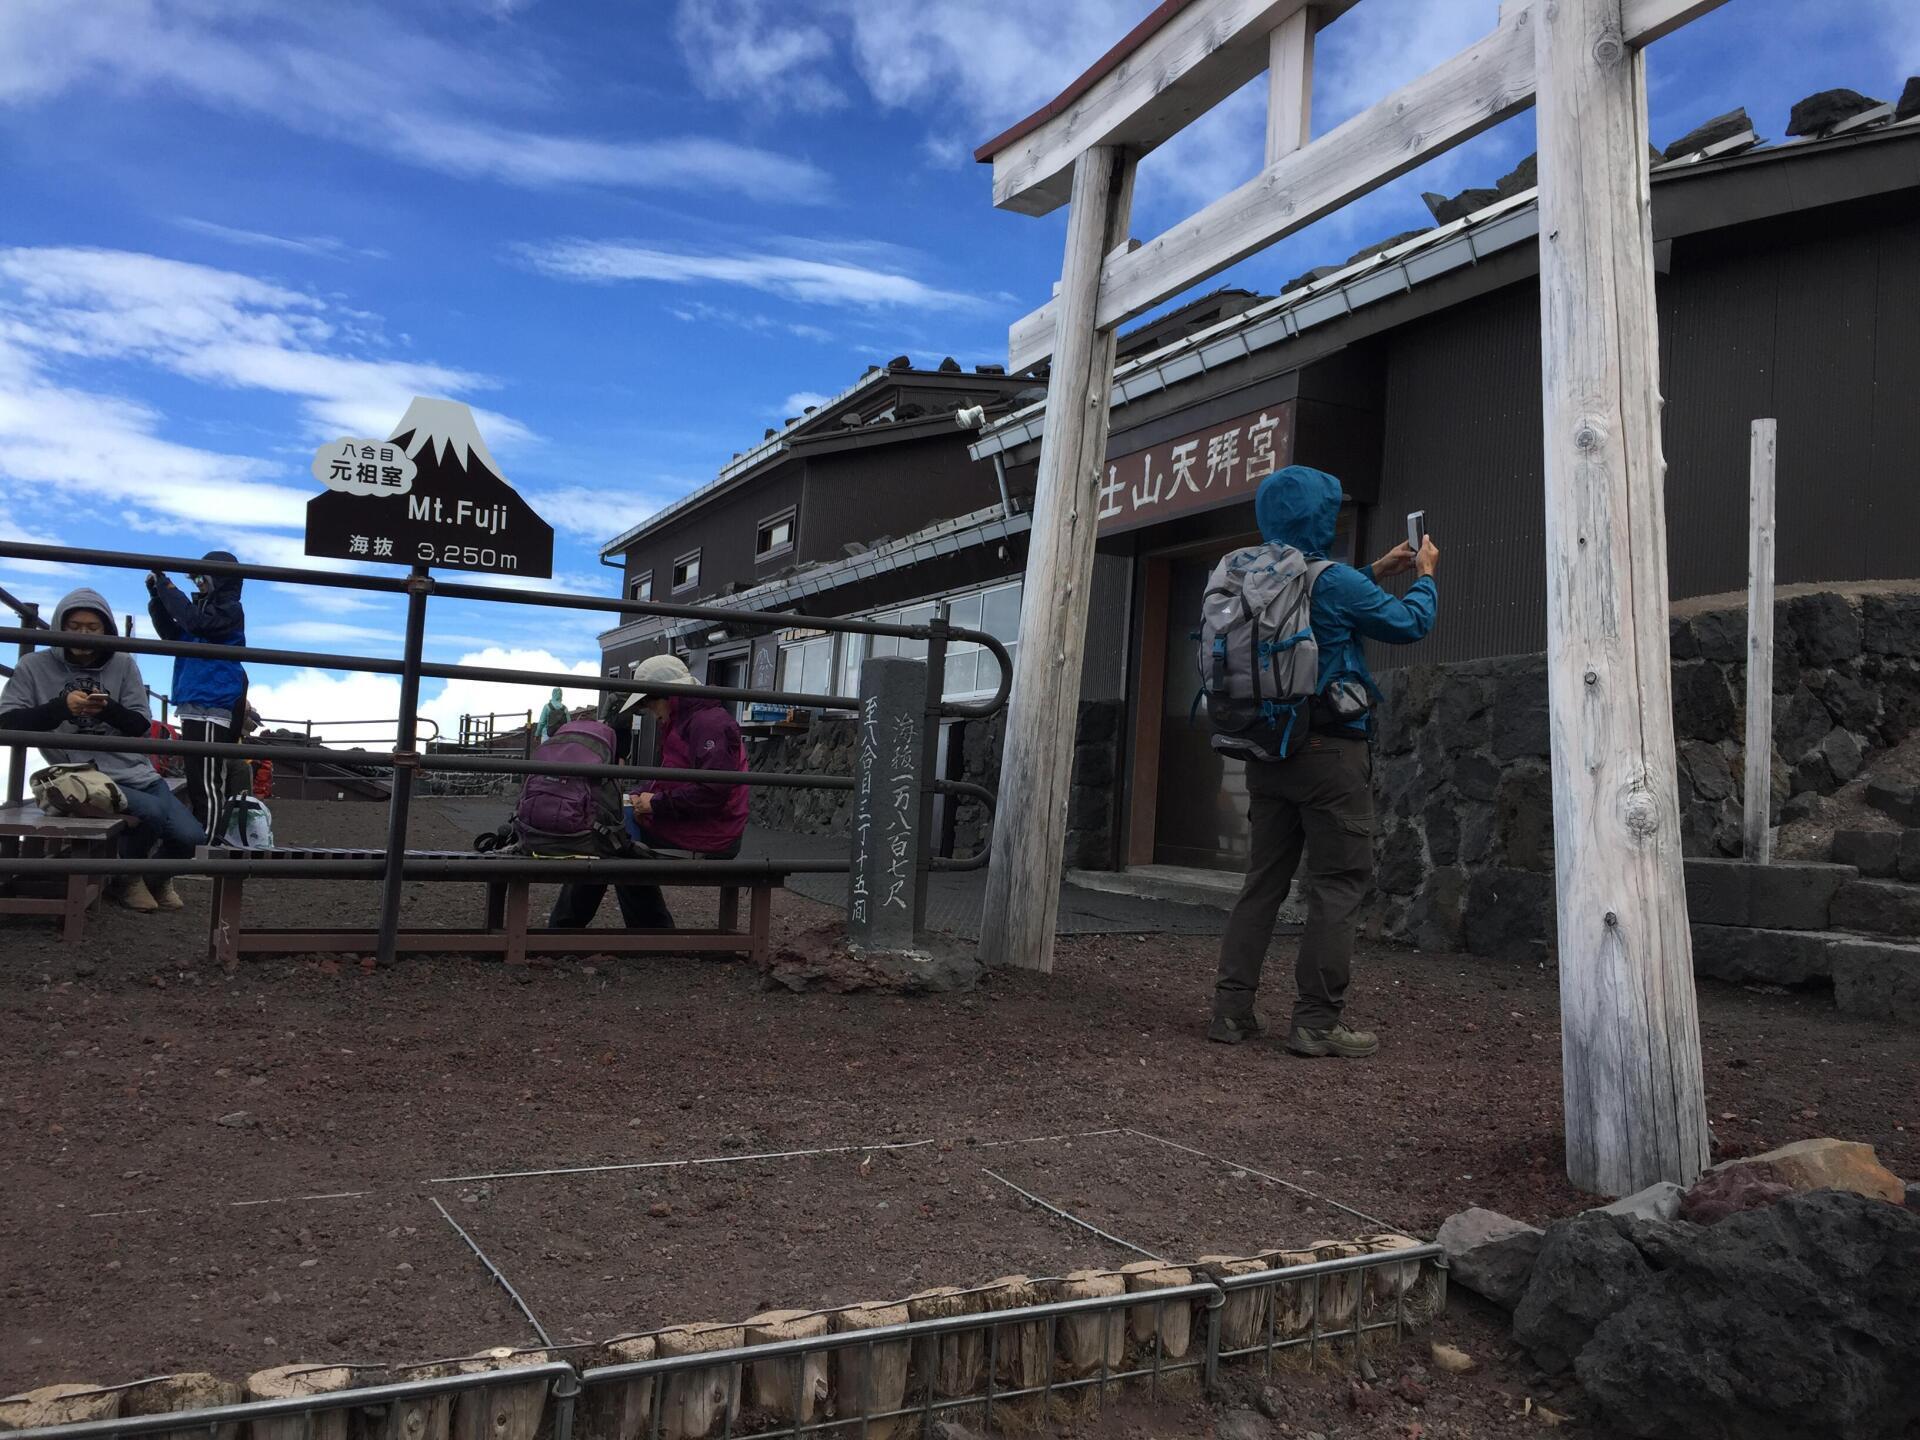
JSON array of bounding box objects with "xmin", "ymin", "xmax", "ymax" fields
[{"xmin": 1213, "ymin": 735, "xmax": 1373, "ymax": 1029}]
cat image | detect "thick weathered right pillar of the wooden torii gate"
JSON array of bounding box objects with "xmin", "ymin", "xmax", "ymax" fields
[{"xmin": 1532, "ymin": 0, "xmax": 1707, "ymax": 1194}]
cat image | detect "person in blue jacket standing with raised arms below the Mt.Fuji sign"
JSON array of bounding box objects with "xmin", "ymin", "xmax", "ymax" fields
[{"xmin": 146, "ymin": 549, "xmax": 246, "ymax": 843}]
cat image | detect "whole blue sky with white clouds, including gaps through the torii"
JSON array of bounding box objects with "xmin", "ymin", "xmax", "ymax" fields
[{"xmin": 0, "ymin": 0, "xmax": 1920, "ymax": 737}]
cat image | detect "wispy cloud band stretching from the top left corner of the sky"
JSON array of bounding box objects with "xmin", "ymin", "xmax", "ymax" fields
[{"xmin": 0, "ymin": 0, "xmax": 831, "ymax": 202}]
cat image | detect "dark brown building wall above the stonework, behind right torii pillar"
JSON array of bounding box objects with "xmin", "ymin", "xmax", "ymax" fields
[{"xmin": 1361, "ymin": 192, "xmax": 1920, "ymax": 668}]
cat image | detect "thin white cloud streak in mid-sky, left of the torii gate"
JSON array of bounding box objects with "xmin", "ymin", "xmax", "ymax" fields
[{"xmin": 524, "ymin": 240, "xmax": 981, "ymax": 311}]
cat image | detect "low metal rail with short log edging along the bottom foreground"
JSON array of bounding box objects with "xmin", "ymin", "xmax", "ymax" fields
[{"xmin": 0, "ymin": 1244, "xmax": 1446, "ymax": 1440}]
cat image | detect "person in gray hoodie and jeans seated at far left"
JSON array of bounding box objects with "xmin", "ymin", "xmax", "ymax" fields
[{"xmin": 0, "ymin": 588, "xmax": 205, "ymax": 910}]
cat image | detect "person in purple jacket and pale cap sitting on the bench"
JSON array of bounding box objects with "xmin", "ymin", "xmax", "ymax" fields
[{"xmin": 547, "ymin": 655, "xmax": 753, "ymax": 929}]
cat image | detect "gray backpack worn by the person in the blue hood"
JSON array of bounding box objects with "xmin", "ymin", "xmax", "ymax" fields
[{"xmin": 1196, "ymin": 545, "xmax": 1332, "ymax": 760}]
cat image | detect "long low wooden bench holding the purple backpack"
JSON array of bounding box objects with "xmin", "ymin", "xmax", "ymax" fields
[{"xmin": 198, "ymin": 845, "xmax": 787, "ymax": 966}]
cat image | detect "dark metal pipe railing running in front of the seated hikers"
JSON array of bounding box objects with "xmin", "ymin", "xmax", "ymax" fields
[{"xmin": 0, "ymin": 541, "xmax": 1014, "ymax": 964}]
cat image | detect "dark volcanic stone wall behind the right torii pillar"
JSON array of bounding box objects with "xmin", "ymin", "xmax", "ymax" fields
[{"xmin": 1367, "ymin": 588, "xmax": 1920, "ymax": 960}]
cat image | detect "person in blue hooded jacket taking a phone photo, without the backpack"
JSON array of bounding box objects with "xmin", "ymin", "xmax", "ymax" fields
[{"xmin": 1208, "ymin": 465, "xmax": 1440, "ymax": 1060}]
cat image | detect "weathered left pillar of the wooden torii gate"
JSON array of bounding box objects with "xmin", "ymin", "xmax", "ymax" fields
[{"xmin": 979, "ymin": 146, "xmax": 1135, "ymax": 972}]
